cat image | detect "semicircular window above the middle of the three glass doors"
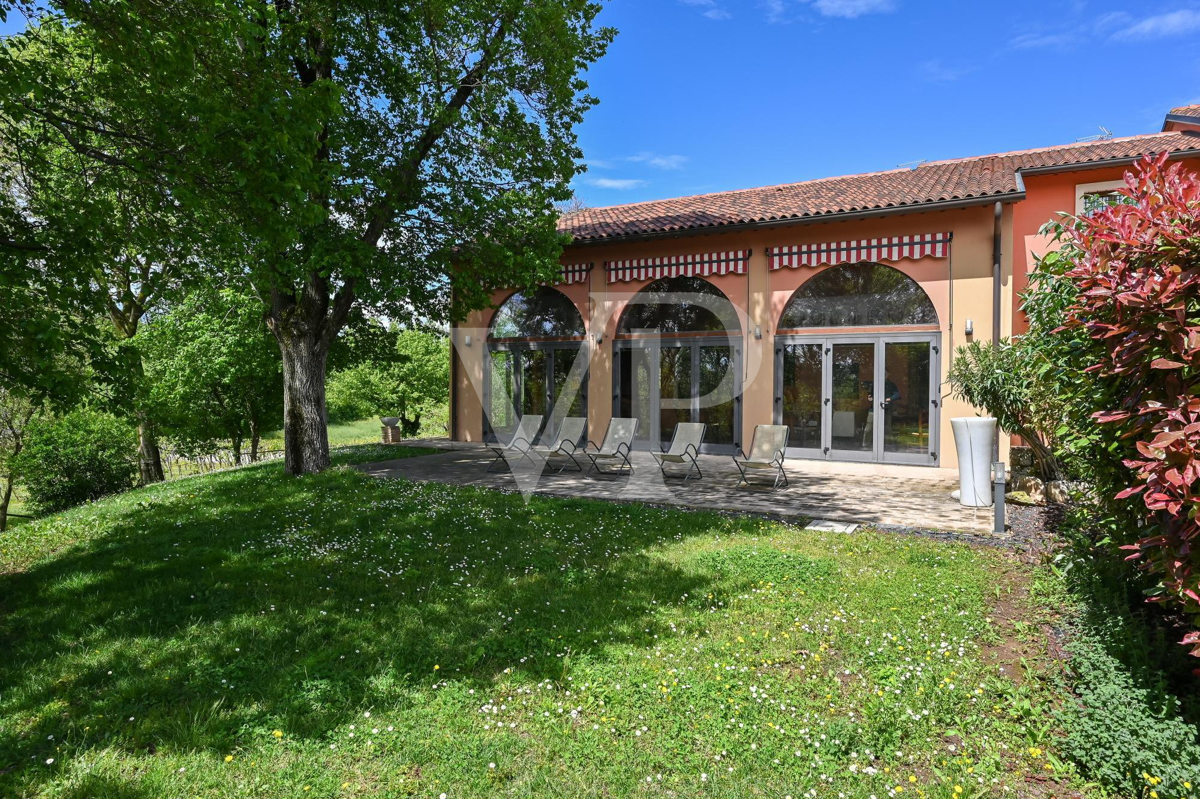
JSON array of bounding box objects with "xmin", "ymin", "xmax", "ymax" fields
[{"xmin": 617, "ymin": 276, "xmax": 740, "ymax": 334}]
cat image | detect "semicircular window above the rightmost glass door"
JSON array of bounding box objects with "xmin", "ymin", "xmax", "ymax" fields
[{"xmin": 779, "ymin": 263, "xmax": 937, "ymax": 330}]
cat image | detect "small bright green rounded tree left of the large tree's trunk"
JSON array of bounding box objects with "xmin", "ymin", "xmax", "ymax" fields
[{"xmin": 134, "ymin": 286, "xmax": 283, "ymax": 463}]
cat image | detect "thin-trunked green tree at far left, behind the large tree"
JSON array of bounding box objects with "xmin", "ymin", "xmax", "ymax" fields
[{"xmin": 0, "ymin": 19, "xmax": 220, "ymax": 482}]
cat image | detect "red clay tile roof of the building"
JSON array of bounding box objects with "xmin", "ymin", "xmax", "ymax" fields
[{"xmin": 558, "ymin": 132, "xmax": 1200, "ymax": 242}]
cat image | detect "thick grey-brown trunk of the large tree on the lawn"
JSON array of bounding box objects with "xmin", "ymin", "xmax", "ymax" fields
[{"xmin": 276, "ymin": 329, "xmax": 329, "ymax": 475}]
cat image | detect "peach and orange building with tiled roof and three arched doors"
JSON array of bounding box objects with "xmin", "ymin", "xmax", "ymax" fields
[{"xmin": 450, "ymin": 106, "xmax": 1200, "ymax": 469}]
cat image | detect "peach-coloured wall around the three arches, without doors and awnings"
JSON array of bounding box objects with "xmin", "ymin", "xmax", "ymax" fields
[{"xmin": 457, "ymin": 205, "xmax": 1013, "ymax": 468}]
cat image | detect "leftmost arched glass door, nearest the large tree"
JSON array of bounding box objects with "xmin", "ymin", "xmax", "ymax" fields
[{"xmin": 484, "ymin": 287, "xmax": 588, "ymax": 440}]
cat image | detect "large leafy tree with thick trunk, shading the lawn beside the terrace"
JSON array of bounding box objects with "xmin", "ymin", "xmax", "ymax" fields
[{"xmin": 4, "ymin": 0, "xmax": 613, "ymax": 474}]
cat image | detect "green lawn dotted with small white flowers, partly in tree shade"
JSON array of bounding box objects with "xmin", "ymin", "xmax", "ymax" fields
[{"xmin": 0, "ymin": 447, "xmax": 1073, "ymax": 799}]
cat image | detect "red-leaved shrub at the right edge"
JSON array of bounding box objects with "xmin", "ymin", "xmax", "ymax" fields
[{"xmin": 1066, "ymin": 155, "xmax": 1200, "ymax": 656}]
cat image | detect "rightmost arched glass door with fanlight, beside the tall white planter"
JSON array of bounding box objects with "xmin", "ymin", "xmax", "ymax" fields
[{"xmin": 775, "ymin": 264, "xmax": 941, "ymax": 464}]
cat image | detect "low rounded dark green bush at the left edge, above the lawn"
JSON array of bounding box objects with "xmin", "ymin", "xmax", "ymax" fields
[{"xmin": 16, "ymin": 407, "xmax": 137, "ymax": 513}]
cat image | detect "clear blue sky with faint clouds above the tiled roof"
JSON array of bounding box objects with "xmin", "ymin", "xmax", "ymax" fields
[{"xmin": 0, "ymin": 0, "xmax": 1200, "ymax": 206}]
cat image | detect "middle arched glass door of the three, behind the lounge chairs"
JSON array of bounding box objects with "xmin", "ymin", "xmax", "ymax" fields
[{"xmin": 613, "ymin": 277, "xmax": 742, "ymax": 452}]
